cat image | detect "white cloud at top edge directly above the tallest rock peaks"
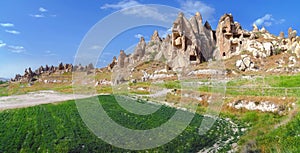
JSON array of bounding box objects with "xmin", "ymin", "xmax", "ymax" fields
[{"xmin": 179, "ymin": 0, "xmax": 215, "ymax": 21}]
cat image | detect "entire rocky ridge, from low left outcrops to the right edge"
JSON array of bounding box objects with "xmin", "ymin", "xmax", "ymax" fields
[{"xmin": 11, "ymin": 12, "xmax": 300, "ymax": 84}]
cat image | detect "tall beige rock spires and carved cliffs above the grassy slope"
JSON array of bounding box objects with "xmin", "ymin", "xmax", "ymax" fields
[{"xmin": 108, "ymin": 12, "xmax": 300, "ymax": 71}]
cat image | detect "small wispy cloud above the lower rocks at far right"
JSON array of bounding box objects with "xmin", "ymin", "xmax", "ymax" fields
[{"xmin": 253, "ymin": 14, "xmax": 285, "ymax": 27}]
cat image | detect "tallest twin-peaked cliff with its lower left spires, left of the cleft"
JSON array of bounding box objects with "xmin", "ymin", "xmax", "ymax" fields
[{"xmin": 111, "ymin": 13, "xmax": 216, "ymax": 69}]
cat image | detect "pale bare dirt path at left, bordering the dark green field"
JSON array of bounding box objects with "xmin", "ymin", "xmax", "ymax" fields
[{"xmin": 0, "ymin": 90, "xmax": 97, "ymax": 110}]
